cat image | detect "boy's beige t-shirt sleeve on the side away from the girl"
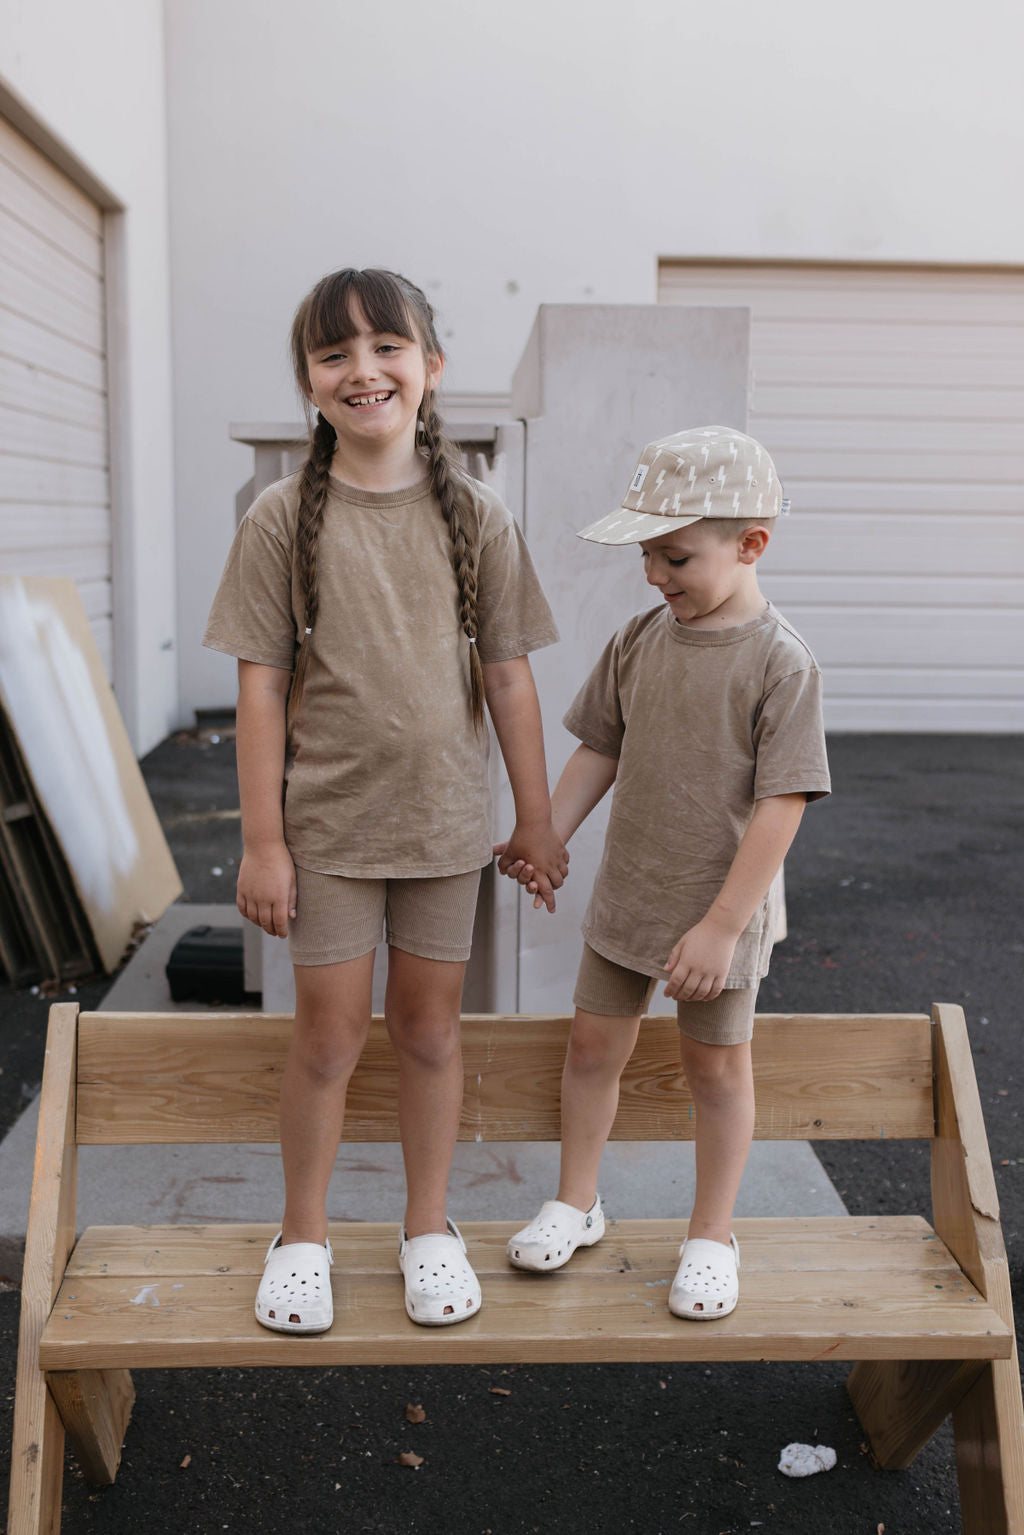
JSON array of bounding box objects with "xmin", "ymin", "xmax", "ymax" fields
[{"xmin": 754, "ymin": 666, "xmax": 832, "ymax": 800}]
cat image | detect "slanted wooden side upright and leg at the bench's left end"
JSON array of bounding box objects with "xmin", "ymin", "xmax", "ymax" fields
[{"xmin": 8, "ymin": 1002, "xmax": 78, "ymax": 1535}]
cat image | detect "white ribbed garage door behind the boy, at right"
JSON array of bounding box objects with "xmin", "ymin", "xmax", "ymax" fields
[{"xmin": 659, "ymin": 261, "xmax": 1024, "ymax": 731}]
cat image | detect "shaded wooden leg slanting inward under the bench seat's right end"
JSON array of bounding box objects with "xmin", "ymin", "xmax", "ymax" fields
[{"xmin": 846, "ymin": 1358, "xmax": 987, "ymax": 1471}]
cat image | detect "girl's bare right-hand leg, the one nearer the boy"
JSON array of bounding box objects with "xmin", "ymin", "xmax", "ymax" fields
[{"xmin": 384, "ymin": 946, "xmax": 465, "ymax": 1239}]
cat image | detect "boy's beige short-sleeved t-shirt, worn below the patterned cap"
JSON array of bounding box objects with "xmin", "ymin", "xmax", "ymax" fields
[{"xmin": 563, "ymin": 606, "xmax": 831, "ymax": 987}]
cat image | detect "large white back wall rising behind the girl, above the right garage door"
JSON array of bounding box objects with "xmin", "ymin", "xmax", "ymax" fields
[{"xmin": 166, "ymin": 0, "xmax": 1024, "ymax": 711}]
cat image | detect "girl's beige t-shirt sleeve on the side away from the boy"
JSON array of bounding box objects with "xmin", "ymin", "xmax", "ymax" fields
[{"xmin": 203, "ymin": 514, "xmax": 295, "ymax": 671}]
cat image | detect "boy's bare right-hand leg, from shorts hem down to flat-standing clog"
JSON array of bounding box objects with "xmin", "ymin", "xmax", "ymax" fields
[{"xmin": 679, "ymin": 1035, "xmax": 754, "ymax": 1245}]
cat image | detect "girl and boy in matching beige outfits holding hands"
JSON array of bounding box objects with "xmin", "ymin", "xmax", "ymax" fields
[{"xmin": 204, "ymin": 269, "xmax": 829, "ymax": 1332}]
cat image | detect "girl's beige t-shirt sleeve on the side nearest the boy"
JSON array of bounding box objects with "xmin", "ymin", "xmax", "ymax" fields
[{"xmin": 476, "ymin": 517, "xmax": 559, "ymax": 662}]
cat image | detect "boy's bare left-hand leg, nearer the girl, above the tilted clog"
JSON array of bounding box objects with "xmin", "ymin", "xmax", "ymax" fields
[{"xmin": 557, "ymin": 1007, "xmax": 640, "ymax": 1210}]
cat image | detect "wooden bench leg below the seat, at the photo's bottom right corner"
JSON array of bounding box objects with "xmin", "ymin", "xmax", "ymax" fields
[{"xmin": 953, "ymin": 1357, "xmax": 1024, "ymax": 1535}]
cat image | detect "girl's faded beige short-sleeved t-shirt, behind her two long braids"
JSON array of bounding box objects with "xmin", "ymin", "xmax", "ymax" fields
[{"xmin": 203, "ymin": 474, "xmax": 557, "ymax": 878}]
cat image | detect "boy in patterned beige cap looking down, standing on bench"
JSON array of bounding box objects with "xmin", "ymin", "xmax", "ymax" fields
[{"xmin": 499, "ymin": 427, "xmax": 829, "ymax": 1322}]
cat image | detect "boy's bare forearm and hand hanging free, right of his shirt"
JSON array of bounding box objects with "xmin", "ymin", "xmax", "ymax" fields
[{"xmin": 665, "ymin": 794, "xmax": 808, "ymax": 1002}]
